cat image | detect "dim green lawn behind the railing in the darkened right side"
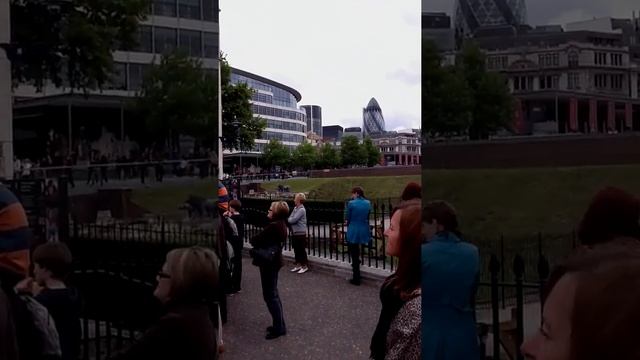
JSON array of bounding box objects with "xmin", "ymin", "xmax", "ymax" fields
[{"xmin": 423, "ymin": 165, "xmax": 640, "ymax": 237}]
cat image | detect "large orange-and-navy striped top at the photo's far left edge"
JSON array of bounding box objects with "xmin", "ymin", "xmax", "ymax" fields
[{"xmin": 0, "ymin": 185, "xmax": 31, "ymax": 278}]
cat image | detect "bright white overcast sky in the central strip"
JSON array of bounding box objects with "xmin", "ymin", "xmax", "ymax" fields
[{"xmin": 220, "ymin": 0, "xmax": 421, "ymax": 130}]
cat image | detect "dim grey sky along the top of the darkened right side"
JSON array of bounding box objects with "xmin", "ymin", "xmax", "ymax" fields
[{"xmin": 422, "ymin": 0, "xmax": 640, "ymax": 25}]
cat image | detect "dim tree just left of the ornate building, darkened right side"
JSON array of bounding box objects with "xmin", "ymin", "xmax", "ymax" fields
[{"xmin": 456, "ymin": 42, "xmax": 514, "ymax": 139}]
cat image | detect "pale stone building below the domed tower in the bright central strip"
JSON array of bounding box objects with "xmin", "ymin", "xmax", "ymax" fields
[{"xmin": 371, "ymin": 130, "xmax": 422, "ymax": 166}]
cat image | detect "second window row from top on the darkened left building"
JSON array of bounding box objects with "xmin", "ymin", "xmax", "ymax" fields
[{"xmin": 134, "ymin": 25, "xmax": 219, "ymax": 59}]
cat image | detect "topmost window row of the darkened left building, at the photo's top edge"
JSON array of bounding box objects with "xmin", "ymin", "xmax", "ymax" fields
[{"xmin": 151, "ymin": 0, "xmax": 219, "ymax": 22}]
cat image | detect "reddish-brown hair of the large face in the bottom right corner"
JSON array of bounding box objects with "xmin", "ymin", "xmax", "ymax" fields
[{"xmin": 543, "ymin": 238, "xmax": 640, "ymax": 360}]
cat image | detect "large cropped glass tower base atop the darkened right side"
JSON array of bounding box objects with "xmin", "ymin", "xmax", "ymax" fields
[{"xmin": 455, "ymin": 0, "xmax": 527, "ymax": 40}]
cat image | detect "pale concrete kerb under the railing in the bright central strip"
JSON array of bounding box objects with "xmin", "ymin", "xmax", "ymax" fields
[{"xmin": 243, "ymin": 244, "xmax": 391, "ymax": 287}]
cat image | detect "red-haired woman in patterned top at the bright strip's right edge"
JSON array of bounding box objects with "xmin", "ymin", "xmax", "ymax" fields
[{"xmin": 371, "ymin": 200, "xmax": 422, "ymax": 360}]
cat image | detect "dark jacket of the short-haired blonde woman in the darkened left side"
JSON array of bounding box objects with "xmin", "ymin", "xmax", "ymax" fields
[{"xmin": 111, "ymin": 304, "xmax": 218, "ymax": 360}]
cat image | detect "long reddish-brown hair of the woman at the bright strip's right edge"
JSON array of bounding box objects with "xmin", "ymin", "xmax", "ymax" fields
[{"xmin": 394, "ymin": 200, "xmax": 422, "ymax": 296}]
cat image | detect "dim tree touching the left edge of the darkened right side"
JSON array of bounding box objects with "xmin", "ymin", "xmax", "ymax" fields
[{"xmin": 422, "ymin": 41, "xmax": 473, "ymax": 139}]
